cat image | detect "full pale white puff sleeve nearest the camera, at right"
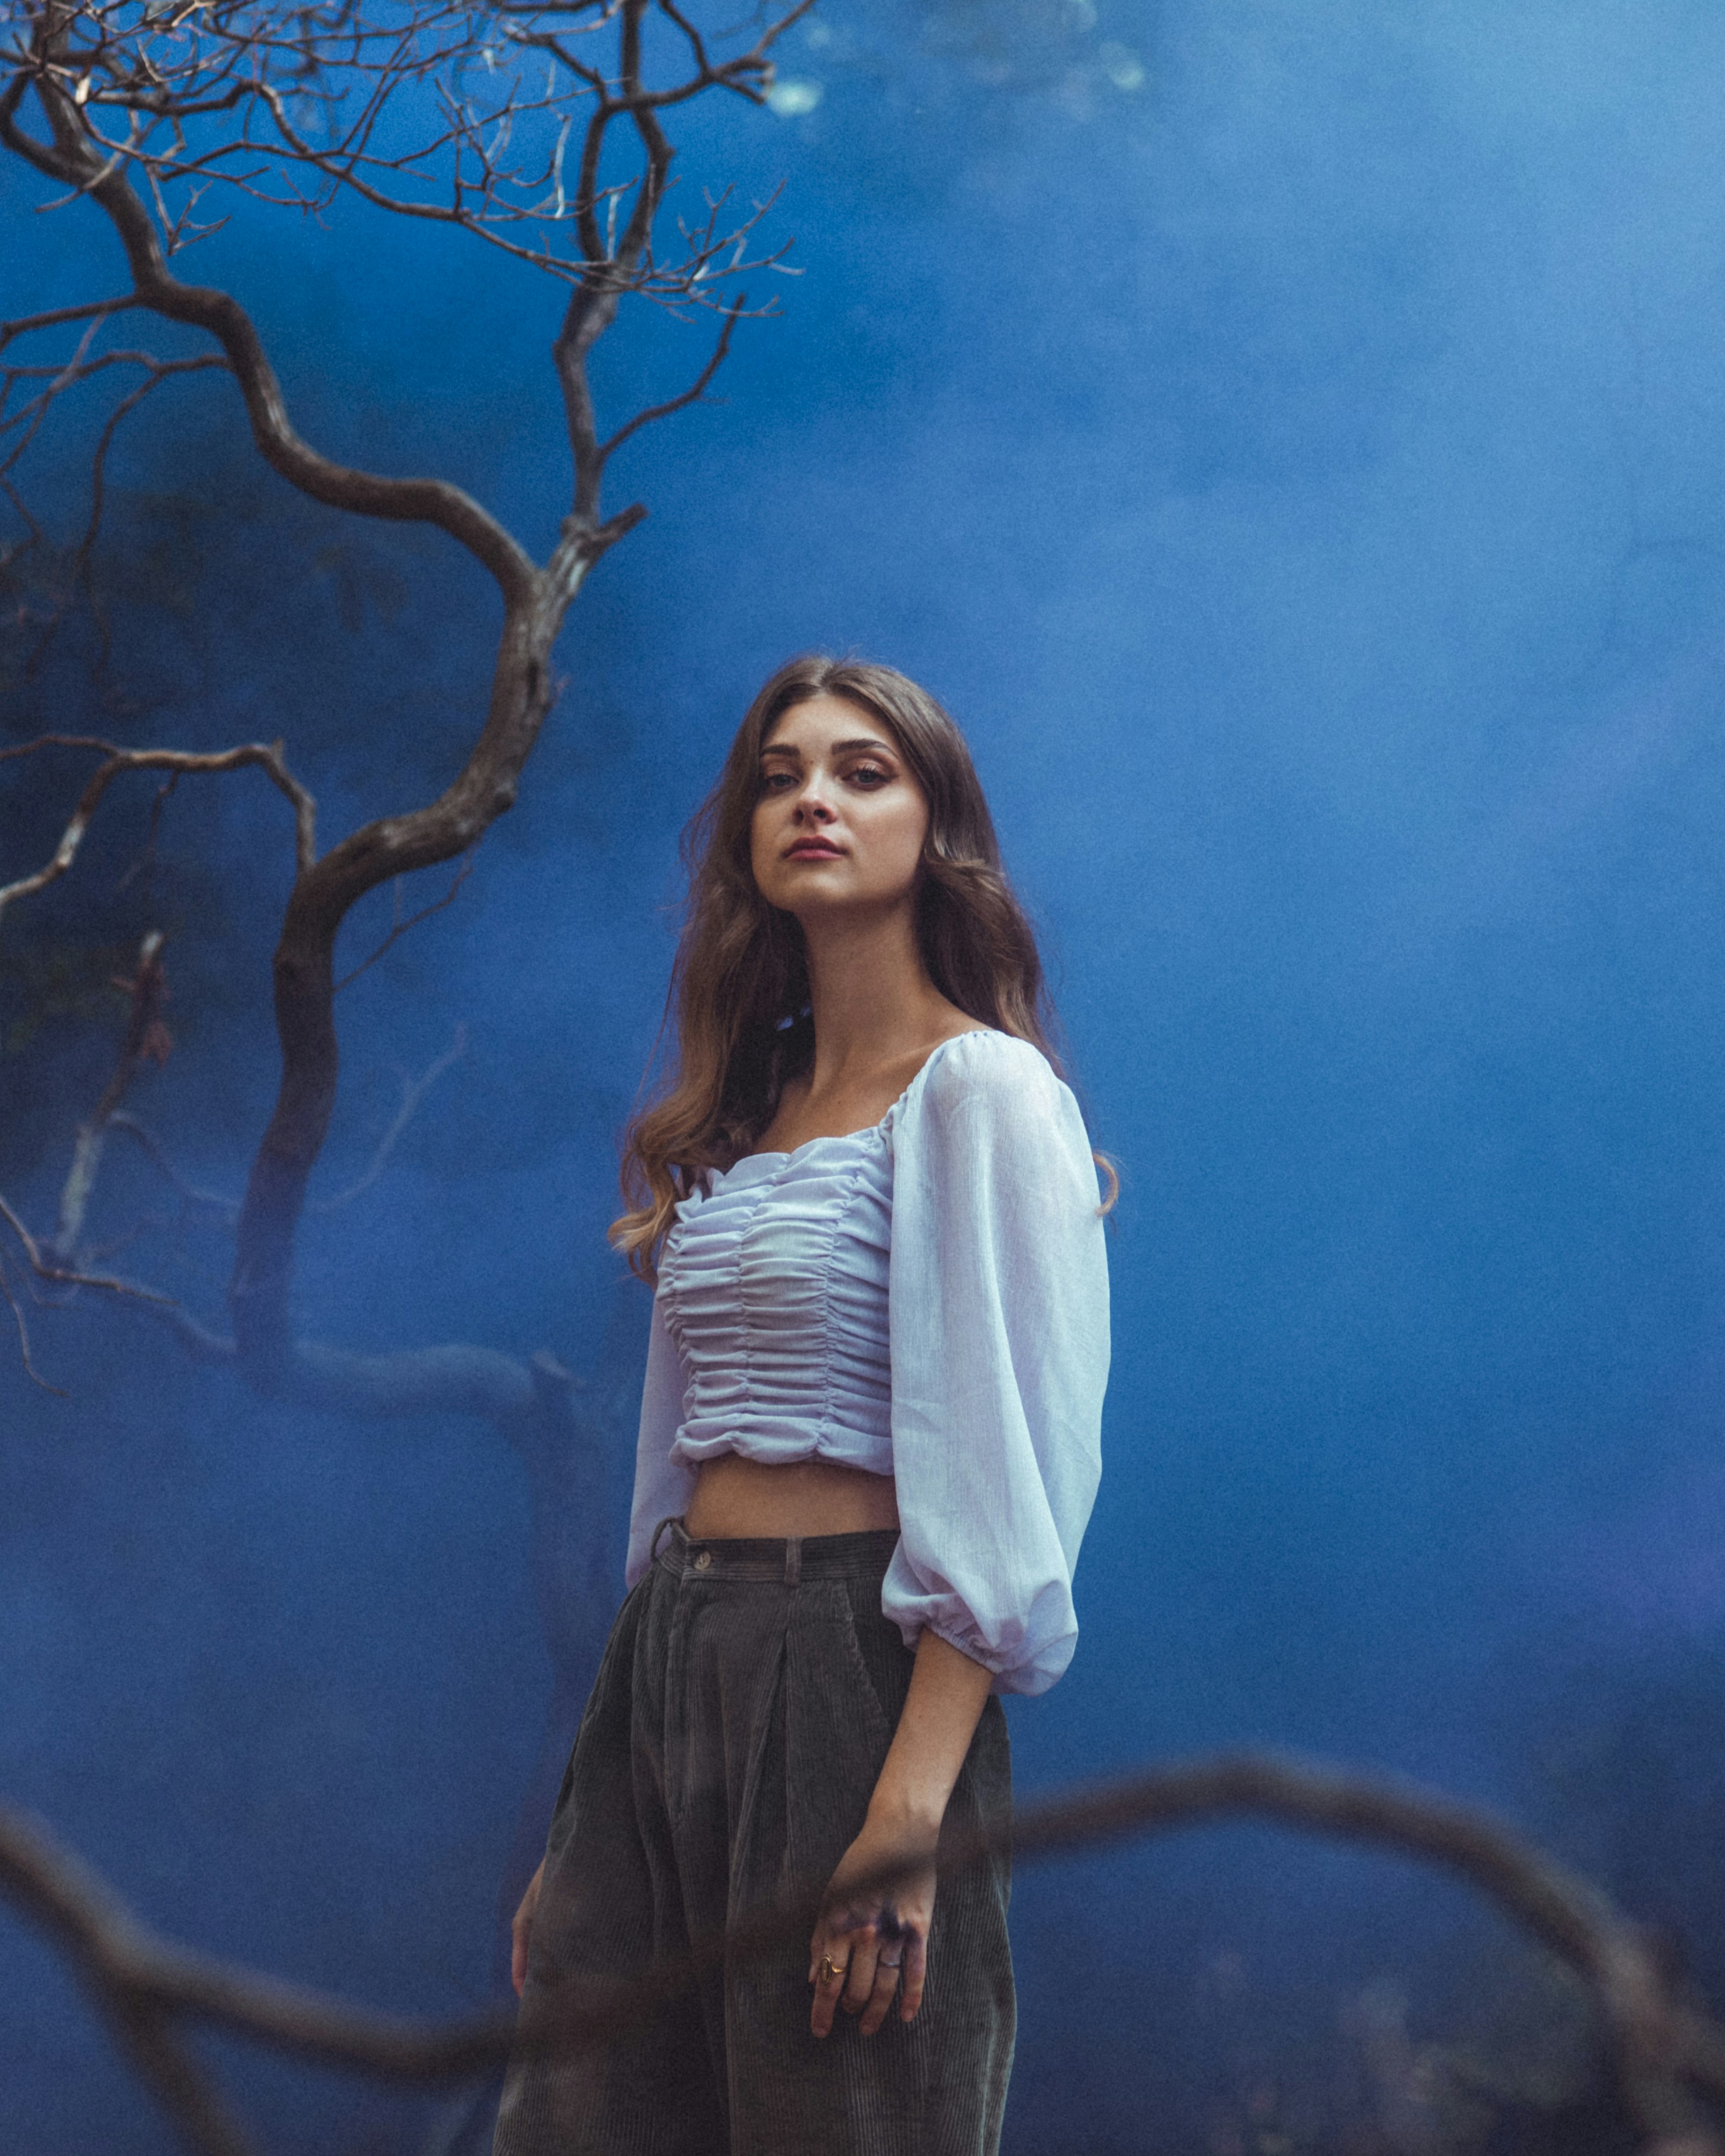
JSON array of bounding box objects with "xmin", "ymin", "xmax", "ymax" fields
[{"xmin": 882, "ymin": 1033, "xmax": 1108, "ymax": 1693}]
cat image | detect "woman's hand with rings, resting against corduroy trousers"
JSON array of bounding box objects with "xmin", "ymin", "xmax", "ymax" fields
[{"xmin": 809, "ymin": 1813, "xmax": 938, "ymax": 2035}]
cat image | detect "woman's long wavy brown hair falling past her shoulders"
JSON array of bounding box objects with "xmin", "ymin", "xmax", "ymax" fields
[{"xmin": 610, "ymin": 653, "xmax": 1059, "ymax": 1281}]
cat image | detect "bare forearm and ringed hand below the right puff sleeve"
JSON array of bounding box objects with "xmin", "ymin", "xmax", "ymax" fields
[{"xmin": 809, "ymin": 1632, "xmax": 994, "ymax": 2035}]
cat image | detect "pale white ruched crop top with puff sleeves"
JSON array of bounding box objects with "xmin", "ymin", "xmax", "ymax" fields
[{"xmin": 628, "ymin": 1031, "xmax": 1108, "ymax": 1693}]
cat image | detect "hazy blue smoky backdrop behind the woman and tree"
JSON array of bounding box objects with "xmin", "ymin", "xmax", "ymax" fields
[{"xmin": 0, "ymin": 0, "xmax": 1725, "ymax": 2156}]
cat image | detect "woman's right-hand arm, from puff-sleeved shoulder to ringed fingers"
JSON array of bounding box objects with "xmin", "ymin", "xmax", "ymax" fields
[{"xmin": 811, "ymin": 1033, "xmax": 1108, "ymax": 2035}]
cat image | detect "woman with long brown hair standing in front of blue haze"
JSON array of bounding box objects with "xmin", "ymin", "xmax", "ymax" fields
[{"xmin": 496, "ymin": 658, "xmax": 1108, "ymax": 2156}]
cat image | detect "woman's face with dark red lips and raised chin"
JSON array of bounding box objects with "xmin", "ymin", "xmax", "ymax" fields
[{"xmin": 751, "ymin": 696, "xmax": 929, "ymax": 919}]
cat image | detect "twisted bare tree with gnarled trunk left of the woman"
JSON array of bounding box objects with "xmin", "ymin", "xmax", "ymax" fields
[{"xmin": 0, "ymin": 0, "xmax": 813, "ymax": 1949}]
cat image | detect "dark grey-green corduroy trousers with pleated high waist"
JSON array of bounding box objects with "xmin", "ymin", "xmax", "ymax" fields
[{"xmin": 496, "ymin": 1522, "xmax": 1014, "ymax": 2156}]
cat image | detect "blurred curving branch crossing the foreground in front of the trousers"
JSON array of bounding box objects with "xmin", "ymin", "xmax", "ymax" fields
[{"xmin": 0, "ymin": 1753, "xmax": 1725, "ymax": 2156}]
